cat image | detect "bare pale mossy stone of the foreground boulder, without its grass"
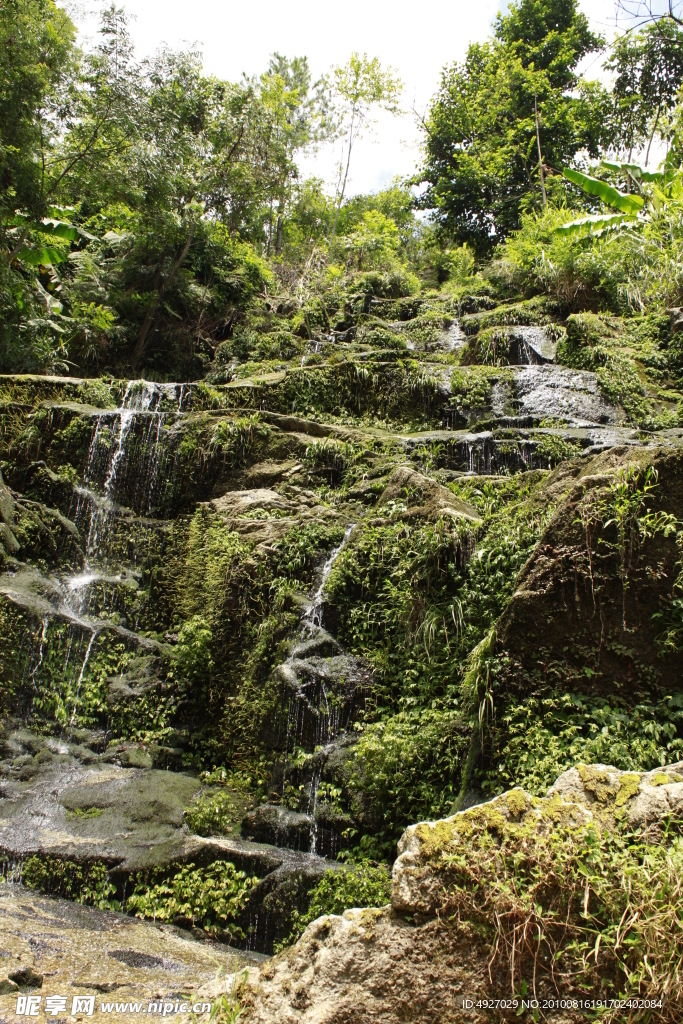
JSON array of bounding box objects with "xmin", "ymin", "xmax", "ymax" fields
[{"xmin": 245, "ymin": 762, "xmax": 683, "ymax": 1024}]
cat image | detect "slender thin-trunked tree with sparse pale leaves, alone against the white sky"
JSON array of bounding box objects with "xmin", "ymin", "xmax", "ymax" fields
[{"xmin": 330, "ymin": 53, "xmax": 402, "ymax": 243}]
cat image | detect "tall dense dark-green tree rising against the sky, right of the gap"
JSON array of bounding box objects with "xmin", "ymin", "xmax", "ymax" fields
[{"xmin": 421, "ymin": 0, "xmax": 609, "ymax": 251}]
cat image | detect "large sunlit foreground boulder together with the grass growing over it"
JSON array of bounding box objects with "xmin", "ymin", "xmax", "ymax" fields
[{"xmin": 240, "ymin": 762, "xmax": 683, "ymax": 1024}]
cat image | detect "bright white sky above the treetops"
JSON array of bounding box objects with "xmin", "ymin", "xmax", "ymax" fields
[{"xmin": 68, "ymin": 0, "xmax": 634, "ymax": 195}]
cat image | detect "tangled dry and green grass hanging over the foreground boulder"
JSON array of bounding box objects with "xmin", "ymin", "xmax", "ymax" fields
[{"xmin": 432, "ymin": 791, "xmax": 683, "ymax": 1020}]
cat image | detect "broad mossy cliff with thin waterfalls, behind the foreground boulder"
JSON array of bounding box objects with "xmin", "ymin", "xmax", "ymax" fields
[{"xmin": 0, "ymin": 282, "xmax": 683, "ymax": 966}]
